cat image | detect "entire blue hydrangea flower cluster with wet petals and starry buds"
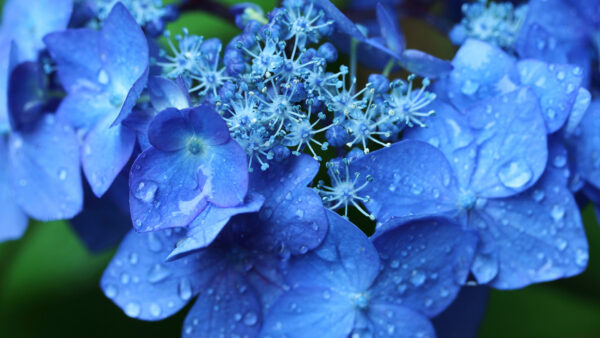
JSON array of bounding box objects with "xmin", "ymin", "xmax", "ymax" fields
[{"xmin": 0, "ymin": 0, "xmax": 600, "ymax": 337}]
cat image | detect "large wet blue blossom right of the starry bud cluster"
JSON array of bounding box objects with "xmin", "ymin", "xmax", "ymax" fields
[{"xmin": 351, "ymin": 89, "xmax": 588, "ymax": 289}]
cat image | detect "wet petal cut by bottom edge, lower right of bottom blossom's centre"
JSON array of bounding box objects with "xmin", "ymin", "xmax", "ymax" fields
[{"xmin": 367, "ymin": 301, "xmax": 435, "ymax": 338}]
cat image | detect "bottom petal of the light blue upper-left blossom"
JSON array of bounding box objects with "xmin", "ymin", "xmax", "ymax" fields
[{"xmin": 81, "ymin": 118, "xmax": 135, "ymax": 197}]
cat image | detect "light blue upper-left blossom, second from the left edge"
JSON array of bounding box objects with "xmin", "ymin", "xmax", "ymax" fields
[{"xmin": 44, "ymin": 3, "xmax": 148, "ymax": 196}]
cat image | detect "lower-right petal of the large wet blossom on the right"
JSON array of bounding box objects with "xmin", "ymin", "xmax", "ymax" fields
[{"xmin": 470, "ymin": 170, "xmax": 588, "ymax": 289}]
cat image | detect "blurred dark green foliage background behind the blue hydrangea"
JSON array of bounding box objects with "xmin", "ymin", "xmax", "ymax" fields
[{"xmin": 0, "ymin": 0, "xmax": 600, "ymax": 337}]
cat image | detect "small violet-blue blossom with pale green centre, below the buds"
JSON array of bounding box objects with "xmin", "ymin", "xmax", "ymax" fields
[{"xmin": 129, "ymin": 105, "xmax": 248, "ymax": 231}]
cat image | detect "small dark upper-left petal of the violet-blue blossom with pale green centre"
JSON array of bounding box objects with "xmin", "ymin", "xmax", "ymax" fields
[{"xmin": 148, "ymin": 108, "xmax": 194, "ymax": 151}]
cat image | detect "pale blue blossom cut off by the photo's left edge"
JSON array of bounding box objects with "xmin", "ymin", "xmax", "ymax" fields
[{"xmin": 0, "ymin": 1, "xmax": 83, "ymax": 241}]
